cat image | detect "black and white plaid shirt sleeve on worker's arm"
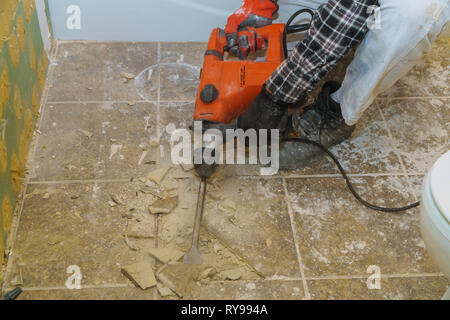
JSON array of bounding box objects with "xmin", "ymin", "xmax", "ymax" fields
[{"xmin": 265, "ymin": 0, "xmax": 378, "ymax": 104}]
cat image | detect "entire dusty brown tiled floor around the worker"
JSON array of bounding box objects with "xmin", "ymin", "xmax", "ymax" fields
[{"xmin": 3, "ymin": 40, "xmax": 450, "ymax": 299}]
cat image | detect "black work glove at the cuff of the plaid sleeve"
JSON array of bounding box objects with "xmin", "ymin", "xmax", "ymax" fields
[{"xmin": 237, "ymin": 86, "xmax": 288, "ymax": 132}]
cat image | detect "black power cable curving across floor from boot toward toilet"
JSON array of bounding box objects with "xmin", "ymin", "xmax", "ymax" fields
[{"xmin": 283, "ymin": 138, "xmax": 420, "ymax": 213}]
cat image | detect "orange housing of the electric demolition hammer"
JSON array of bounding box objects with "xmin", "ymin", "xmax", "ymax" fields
[{"xmin": 194, "ymin": 24, "xmax": 285, "ymax": 124}]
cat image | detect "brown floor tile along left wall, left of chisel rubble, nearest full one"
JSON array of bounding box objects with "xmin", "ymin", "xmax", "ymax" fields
[{"xmin": 5, "ymin": 183, "xmax": 156, "ymax": 287}]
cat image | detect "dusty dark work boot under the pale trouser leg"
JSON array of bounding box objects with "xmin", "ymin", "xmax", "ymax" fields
[{"xmin": 280, "ymin": 81, "xmax": 355, "ymax": 169}]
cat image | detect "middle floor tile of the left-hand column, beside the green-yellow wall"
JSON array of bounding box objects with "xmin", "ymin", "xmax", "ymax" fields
[{"xmin": 32, "ymin": 103, "xmax": 157, "ymax": 181}]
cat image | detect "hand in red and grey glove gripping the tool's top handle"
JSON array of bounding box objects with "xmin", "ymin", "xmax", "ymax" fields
[{"xmin": 225, "ymin": 0, "xmax": 278, "ymax": 57}]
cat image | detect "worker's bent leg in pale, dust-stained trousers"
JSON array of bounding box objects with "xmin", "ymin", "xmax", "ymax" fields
[{"xmin": 331, "ymin": 0, "xmax": 450, "ymax": 125}]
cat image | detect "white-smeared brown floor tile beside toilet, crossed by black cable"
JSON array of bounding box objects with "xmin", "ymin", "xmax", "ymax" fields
[{"xmin": 287, "ymin": 177, "xmax": 438, "ymax": 276}]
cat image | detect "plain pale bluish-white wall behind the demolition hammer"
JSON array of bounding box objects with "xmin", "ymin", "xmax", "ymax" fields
[{"xmin": 45, "ymin": 0, "xmax": 318, "ymax": 41}]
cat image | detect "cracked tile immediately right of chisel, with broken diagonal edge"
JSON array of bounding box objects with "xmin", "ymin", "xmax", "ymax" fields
[{"xmin": 203, "ymin": 175, "xmax": 300, "ymax": 277}]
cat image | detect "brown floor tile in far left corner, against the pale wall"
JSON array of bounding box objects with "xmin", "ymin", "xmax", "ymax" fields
[{"xmin": 48, "ymin": 42, "xmax": 158, "ymax": 101}]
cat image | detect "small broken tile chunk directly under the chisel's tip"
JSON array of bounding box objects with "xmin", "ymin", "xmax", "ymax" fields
[{"xmin": 156, "ymin": 263, "xmax": 195, "ymax": 298}]
